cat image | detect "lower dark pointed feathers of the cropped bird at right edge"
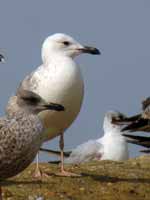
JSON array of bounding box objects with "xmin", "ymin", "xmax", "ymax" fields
[{"xmin": 123, "ymin": 134, "xmax": 150, "ymax": 153}]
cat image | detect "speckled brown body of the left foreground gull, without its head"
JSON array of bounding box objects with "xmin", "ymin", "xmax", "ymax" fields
[{"xmin": 0, "ymin": 110, "xmax": 43, "ymax": 179}]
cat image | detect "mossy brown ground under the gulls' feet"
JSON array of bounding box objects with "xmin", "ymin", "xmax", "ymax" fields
[{"xmin": 1, "ymin": 156, "xmax": 150, "ymax": 200}]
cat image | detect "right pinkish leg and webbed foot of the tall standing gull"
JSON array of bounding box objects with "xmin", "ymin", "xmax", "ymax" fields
[{"xmin": 56, "ymin": 133, "xmax": 80, "ymax": 176}]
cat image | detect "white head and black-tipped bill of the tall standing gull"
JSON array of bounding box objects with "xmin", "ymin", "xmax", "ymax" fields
[{"xmin": 42, "ymin": 33, "xmax": 100, "ymax": 61}]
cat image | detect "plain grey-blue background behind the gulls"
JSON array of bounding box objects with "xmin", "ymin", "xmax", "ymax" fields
[{"xmin": 0, "ymin": 0, "xmax": 150, "ymax": 158}]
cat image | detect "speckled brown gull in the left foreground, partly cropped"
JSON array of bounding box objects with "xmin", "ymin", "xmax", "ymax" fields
[{"xmin": 0, "ymin": 90, "xmax": 64, "ymax": 199}]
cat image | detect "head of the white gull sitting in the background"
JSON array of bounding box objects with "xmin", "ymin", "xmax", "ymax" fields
[{"xmin": 103, "ymin": 111, "xmax": 125, "ymax": 133}]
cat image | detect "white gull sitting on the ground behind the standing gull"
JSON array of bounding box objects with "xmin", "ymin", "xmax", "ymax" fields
[{"xmin": 40, "ymin": 111, "xmax": 129, "ymax": 164}]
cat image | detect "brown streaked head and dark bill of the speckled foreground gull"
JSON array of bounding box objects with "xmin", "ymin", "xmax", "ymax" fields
[{"xmin": 17, "ymin": 90, "xmax": 64, "ymax": 114}]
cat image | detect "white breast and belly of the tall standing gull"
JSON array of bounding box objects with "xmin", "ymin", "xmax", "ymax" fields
[{"xmin": 27, "ymin": 59, "xmax": 84, "ymax": 140}]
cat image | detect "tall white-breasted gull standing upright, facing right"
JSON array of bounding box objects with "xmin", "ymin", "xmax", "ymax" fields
[{"xmin": 10, "ymin": 33, "xmax": 100, "ymax": 176}]
